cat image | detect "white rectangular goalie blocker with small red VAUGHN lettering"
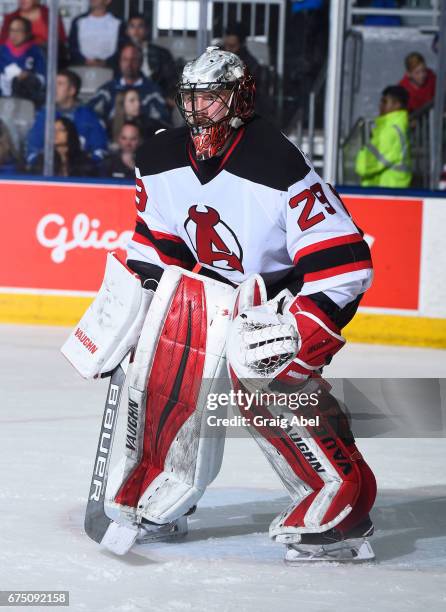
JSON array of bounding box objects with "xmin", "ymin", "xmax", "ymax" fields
[{"xmin": 61, "ymin": 253, "xmax": 153, "ymax": 378}]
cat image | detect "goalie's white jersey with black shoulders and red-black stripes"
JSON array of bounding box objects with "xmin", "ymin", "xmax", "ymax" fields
[{"xmin": 128, "ymin": 117, "xmax": 372, "ymax": 308}]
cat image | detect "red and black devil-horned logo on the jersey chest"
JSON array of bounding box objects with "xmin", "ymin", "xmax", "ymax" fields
[{"xmin": 184, "ymin": 205, "xmax": 244, "ymax": 274}]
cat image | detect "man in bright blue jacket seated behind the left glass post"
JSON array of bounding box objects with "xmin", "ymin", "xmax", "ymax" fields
[{"xmin": 26, "ymin": 70, "xmax": 107, "ymax": 165}]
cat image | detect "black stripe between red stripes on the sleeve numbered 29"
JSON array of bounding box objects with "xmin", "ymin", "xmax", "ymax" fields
[{"xmin": 296, "ymin": 240, "xmax": 372, "ymax": 275}]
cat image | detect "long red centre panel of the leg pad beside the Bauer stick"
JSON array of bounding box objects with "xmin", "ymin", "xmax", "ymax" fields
[{"xmin": 115, "ymin": 276, "xmax": 207, "ymax": 507}]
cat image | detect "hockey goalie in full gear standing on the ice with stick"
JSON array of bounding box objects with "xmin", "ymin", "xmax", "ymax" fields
[{"xmin": 63, "ymin": 47, "xmax": 376, "ymax": 564}]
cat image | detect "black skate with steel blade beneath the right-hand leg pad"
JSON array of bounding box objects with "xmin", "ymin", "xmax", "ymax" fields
[{"xmin": 285, "ymin": 518, "xmax": 375, "ymax": 565}]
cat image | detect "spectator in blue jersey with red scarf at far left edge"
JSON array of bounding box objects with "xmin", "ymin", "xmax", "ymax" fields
[{"xmin": 0, "ymin": 17, "xmax": 46, "ymax": 106}]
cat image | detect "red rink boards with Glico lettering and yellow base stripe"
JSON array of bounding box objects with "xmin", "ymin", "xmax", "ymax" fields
[{"xmin": 0, "ymin": 180, "xmax": 446, "ymax": 348}]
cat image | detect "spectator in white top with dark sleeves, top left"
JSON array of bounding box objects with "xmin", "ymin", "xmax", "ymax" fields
[{"xmin": 69, "ymin": 0, "xmax": 122, "ymax": 67}]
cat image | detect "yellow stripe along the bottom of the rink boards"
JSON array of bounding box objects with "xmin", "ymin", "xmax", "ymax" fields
[{"xmin": 0, "ymin": 293, "xmax": 446, "ymax": 349}]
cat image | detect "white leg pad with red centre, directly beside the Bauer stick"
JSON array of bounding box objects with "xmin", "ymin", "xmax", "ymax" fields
[{"xmin": 106, "ymin": 266, "xmax": 234, "ymax": 524}]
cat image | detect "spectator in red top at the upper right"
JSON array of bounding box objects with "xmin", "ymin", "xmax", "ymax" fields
[{"xmin": 399, "ymin": 52, "xmax": 436, "ymax": 113}]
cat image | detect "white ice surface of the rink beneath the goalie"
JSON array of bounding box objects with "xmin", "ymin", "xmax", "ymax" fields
[{"xmin": 0, "ymin": 326, "xmax": 446, "ymax": 612}]
